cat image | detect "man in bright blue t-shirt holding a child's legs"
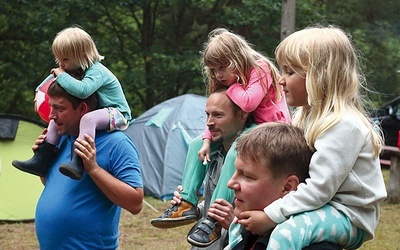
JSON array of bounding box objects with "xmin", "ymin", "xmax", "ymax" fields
[{"xmin": 35, "ymin": 81, "xmax": 143, "ymax": 250}]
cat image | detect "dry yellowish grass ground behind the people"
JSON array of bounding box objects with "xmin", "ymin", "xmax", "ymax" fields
[{"xmin": 0, "ymin": 170, "xmax": 400, "ymax": 250}]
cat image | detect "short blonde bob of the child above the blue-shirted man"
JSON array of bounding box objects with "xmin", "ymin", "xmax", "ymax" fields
[{"xmin": 51, "ymin": 26, "xmax": 104, "ymax": 71}]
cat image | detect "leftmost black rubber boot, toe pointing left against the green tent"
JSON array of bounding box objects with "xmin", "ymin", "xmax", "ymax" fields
[{"xmin": 12, "ymin": 141, "xmax": 56, "ymax": 177}]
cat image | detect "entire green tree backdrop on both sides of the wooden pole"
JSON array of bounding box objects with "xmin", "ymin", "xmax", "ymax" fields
[{"xmin": 0, "ymin": 0, "xmax": 400, "ymax": 121}]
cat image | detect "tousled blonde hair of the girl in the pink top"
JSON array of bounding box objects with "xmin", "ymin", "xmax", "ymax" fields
[{"xmin": 201, "ymin": 28, "xmax": 281, "ymax": 101}]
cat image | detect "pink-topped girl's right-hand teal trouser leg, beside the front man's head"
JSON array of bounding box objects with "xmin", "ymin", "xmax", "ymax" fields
[{"xmin": 210, "ymin": 140, "xmax": 237, "ymax": 204}]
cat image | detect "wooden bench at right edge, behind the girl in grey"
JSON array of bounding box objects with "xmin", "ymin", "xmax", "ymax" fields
[{"xmin": 383, "ymin": 146, "xmax": 400, "ymax": 204}]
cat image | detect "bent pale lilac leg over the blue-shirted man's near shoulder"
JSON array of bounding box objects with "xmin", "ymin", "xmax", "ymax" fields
[{"xmin": 78, "ymin": 108, "xmax": 110, "ymax": 139}]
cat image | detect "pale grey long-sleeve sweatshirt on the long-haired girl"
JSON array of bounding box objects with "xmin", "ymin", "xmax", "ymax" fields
[{"xmin": 264, "ymin": 114, "xmax": 387, "ymax": 239}]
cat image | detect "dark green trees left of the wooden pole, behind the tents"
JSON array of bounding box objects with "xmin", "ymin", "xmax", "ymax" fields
[{"xmin": 2, "ymin": 0, "xmax": 280, "ymax": 119}]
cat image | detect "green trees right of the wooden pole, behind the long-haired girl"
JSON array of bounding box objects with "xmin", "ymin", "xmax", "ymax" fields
[{"xmin": 297, "ymin": 0, "xmax": 400, "ymax": 105}]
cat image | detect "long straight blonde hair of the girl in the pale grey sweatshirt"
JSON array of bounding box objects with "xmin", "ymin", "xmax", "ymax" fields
[{"xmin": 275, "ymin": 26, "xmax": 383, "ymax": 156}]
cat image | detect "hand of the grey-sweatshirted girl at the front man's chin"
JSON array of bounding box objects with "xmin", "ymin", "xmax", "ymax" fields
[{"xmin": 237, "ymin": 211, "xmax": 276, "ymax": 235}]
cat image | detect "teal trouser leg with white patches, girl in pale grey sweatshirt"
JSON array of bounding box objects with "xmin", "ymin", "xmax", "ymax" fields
[{"xmin": 267, "ymin": 205, "xmax": 365, "ymax": 249}]
